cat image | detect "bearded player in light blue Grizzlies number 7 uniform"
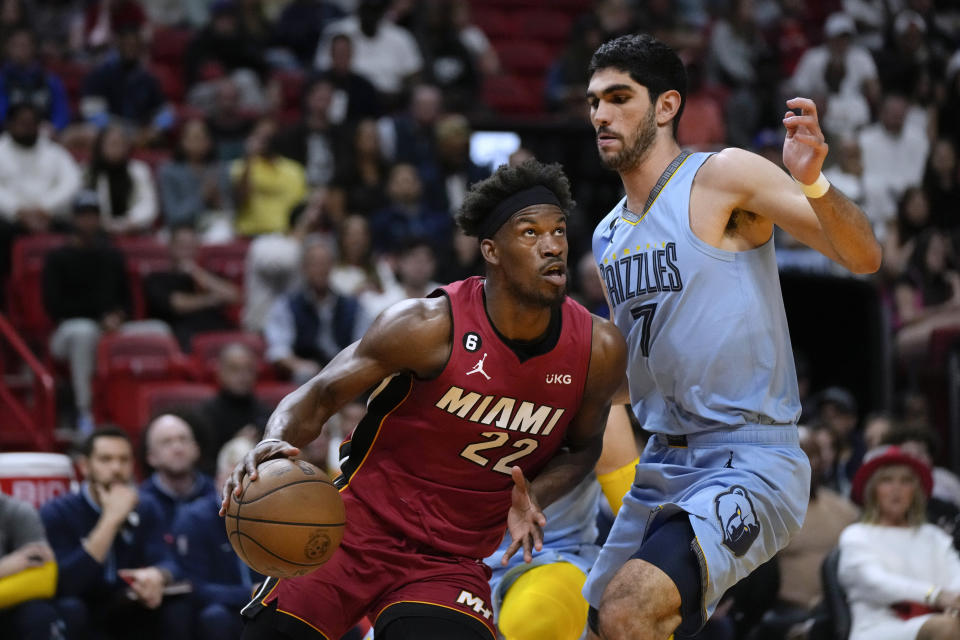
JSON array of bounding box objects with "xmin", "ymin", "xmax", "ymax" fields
[{"xmin": 584, "ymin": 35, "xmax": 880, "ymax": 640}]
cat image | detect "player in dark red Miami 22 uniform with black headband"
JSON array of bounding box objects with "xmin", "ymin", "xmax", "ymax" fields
[{"xmin": 221, "ymin": 161, "xmax": 626, "ymax": 640}]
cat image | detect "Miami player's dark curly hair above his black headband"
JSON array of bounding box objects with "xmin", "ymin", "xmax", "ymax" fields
[{"xmin": 457, "ymin": 160, "xmax": 576, "ymax": 237}]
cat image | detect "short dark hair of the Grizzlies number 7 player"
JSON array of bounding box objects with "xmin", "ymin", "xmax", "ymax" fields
[{"xmin": 588, "ymin": 33, "xmax": 687, "ymax": 136}]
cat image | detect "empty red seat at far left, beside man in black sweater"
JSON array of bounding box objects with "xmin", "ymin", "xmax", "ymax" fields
[{"xmin": 7, "ymin": 234, "xmax": 66, "ymax": 343}]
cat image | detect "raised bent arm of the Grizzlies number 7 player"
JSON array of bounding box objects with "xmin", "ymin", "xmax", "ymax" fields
[{"xmin": 698, "ymin": 98, "xmax": 881, "ymax": 273}]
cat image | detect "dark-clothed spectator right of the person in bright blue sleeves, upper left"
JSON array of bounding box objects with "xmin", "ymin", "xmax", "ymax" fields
[{"xmin": 80, "ymin": 24, "xmax": 173, "ymax": 140}]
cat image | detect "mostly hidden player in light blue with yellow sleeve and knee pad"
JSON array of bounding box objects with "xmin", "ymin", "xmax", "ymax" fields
[{"xmin": 484, "ymin": 405, "xmax": 637, "ymax": 640}]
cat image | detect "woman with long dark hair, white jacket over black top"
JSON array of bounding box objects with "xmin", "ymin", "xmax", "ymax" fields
[{"xmin": 86, "ymin": 124, "xmax": 158, "ymax": 234}]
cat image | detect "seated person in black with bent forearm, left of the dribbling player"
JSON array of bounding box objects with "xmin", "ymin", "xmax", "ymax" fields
[{"xmin": 143, "ymin": 225, "xmax": 240, "ymax": 352}]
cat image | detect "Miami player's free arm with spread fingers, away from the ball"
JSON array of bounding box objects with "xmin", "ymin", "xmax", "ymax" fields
[{"xmin": 502, "ymin": 317, "xmax": 627, "ymax": 563}]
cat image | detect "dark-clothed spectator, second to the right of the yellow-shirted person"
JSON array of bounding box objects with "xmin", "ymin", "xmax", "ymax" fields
[{"xmin": 329, "ymin": 118, "xmax": 387, "ymax": 224}]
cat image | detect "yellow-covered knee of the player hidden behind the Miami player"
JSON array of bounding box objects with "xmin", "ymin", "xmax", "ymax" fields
[{"xmin": 497, "ymin": 562, "xmax": 588, "ymax": 640}]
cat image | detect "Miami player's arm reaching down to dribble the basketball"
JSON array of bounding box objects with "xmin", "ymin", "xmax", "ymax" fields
[{"xmin": 220, "ymin": 297, "xmax": 451, "ymax": 515}]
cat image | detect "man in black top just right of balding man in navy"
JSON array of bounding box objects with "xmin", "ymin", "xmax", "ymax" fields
[{"xmin": 199, "ymin": 342, "xmax": 270, "ymax": 460}]
